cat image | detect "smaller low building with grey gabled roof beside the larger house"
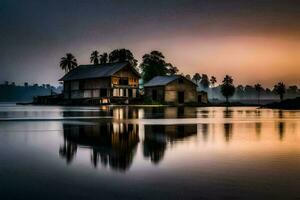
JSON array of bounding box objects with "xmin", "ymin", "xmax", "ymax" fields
[{"xmin": 144, "ymin": 75, "xmax": 198, "ymax": 104}]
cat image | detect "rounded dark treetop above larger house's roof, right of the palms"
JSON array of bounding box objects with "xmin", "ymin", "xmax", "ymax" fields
[{"xmin": 108, "ymin": 49, "xmax": 137, "ymax": 67}]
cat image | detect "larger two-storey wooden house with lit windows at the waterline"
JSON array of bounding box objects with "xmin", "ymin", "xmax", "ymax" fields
[{"xmin": 59, "ymin": 62, "xmax": 140, "ymax": 103}]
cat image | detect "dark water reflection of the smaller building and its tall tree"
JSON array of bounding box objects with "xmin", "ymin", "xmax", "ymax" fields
[{"xmin": 143, "ymin": 124, "xmax": 197, "ymax": 164}]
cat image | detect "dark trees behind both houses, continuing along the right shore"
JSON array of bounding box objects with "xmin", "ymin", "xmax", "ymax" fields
[{"xmin": 60, "ymin": 48, "xmax": 300, "ymax": 103}]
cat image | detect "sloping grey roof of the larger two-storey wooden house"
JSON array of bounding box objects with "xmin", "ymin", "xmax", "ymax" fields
[{"xmin": 59, "ymin": 62, "xmax": 140, "ymax": 81}]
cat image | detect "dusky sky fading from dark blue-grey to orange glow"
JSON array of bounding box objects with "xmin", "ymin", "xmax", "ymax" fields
[{"xmin": 0, "ymin": 0, "xmax": 300, "ymax": 87}]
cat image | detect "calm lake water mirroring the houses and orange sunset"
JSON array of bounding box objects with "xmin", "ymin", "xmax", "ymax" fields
[{"xmin": 0, "ymin": 105, "xmax": 300, "ymax": 199}]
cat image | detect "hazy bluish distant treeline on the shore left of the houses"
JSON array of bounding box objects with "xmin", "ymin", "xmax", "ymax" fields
[{"xmin": 0, "ymin": 81, "xmax": 62, "ymax": 102}]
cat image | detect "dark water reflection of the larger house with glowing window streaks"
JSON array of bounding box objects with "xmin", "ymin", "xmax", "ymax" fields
[{"xmin": 59, "ymin": 122, "xmax": 139, "ymax": 171}]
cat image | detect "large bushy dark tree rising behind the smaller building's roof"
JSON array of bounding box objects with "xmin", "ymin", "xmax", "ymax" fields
[{"xmin": 139, "ymin": 51, "xmax": 178, "ymax": 82}]
